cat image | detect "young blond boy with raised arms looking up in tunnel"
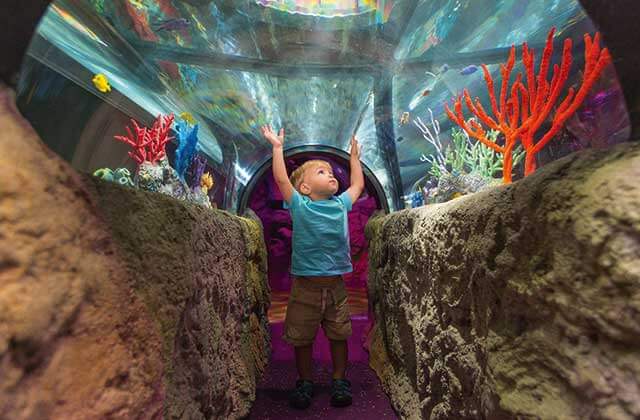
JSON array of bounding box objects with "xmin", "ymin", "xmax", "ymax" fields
[{"xmin": 261, "ymin": 126, "xmax": 364, "ymax": 408}]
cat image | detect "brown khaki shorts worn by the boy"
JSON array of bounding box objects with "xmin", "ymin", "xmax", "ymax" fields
[{"xmin": 282, "ymin": 276, "xmax": 351, "ymax": 347}]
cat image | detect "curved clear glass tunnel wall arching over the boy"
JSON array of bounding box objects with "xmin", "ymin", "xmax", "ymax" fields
[{"xmin": 18, "ymin": 0, "xmax": 630, "ymax": 211}]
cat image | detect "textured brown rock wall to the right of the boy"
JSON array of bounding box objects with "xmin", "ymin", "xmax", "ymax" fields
[{"xmin": 367, "ymin": 143, "xmax": 640, "ymax": 419}]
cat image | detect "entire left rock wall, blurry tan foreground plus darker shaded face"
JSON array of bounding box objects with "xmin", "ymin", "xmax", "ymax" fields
[{"xmin": 0, "ymin": 87, "xmax": 270, "ymax": 419}]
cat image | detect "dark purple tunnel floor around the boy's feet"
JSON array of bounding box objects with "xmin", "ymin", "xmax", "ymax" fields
[{"xmin": 248, "ymin": 288, "xmax": 398, "ymax": 420}]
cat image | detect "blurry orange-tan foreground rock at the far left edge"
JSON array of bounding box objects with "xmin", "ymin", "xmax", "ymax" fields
[{"xmin": 0, "ymin": 89, "xmax": 165, "ymax": 419}]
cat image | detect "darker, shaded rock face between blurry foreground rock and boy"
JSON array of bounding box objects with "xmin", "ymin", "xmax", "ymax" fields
[{"xmin": 86, "ymin": 177, "xmax": 270, "ymax": 419}]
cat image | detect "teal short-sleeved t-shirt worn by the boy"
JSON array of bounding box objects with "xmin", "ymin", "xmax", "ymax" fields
[{"xmin": 285, "ymin": 190, "xmax": 353, "ymax": 276}]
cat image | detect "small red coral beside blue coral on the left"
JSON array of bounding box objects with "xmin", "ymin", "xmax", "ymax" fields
[{"xmin": 114, "ymin": 114, "xmax": 174, "ymax": 164}]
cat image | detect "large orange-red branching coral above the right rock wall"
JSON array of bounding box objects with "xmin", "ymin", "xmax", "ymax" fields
[{"xmin": 445, "ymin": 28, "xmax": 611, "ymax": 183}]
